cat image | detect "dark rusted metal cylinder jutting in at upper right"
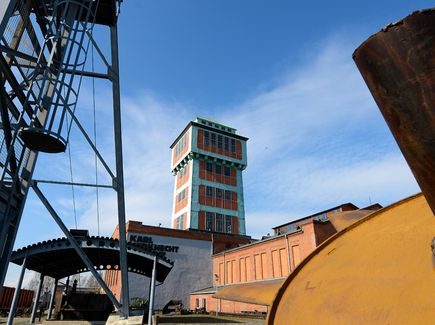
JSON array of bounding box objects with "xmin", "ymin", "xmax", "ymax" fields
[{"xmin": 353, "ymin": 9, "xmax": 435, "ymax": 213}]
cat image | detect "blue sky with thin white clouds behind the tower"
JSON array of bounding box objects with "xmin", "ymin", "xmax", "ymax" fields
[{"xmin": 6, "ymin": 0, "xmax": 433, "ymax": 284}]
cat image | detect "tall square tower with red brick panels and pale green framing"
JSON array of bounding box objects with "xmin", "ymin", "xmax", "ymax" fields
[{"xmin": 171, "ymin": 117, "xmax": 248, "ymax": 235}]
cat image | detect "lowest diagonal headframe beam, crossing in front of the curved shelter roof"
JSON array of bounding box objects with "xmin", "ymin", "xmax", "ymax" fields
[{"xmin": 32, "ymin": 183, "xmax": 121, "ymax": 309}]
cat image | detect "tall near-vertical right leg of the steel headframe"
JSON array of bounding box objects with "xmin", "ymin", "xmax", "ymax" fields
[{"xmin": 110, "ymin": 25, "xmax": 130, "ymax": 318}]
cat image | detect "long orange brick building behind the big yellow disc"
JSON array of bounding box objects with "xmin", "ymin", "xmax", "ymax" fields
[{"xmin": 190, "ymin": 203, "xmax": 381, "ymax": 313}]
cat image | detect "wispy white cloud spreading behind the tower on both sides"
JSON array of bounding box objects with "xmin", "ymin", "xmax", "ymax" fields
[{"xmin": 20, "ymin": 37, "xmax": 418, "ymax": 236}]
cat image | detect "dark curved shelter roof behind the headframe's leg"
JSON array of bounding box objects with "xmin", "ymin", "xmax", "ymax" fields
[{"xmin": 11, "ymin": 236, "xmax": 173, "ymax": 282}]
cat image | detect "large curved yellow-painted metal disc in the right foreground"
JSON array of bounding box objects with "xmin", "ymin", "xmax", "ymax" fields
[{"xmin": 267, "ymin": 194, "xmax": 435, "ymax": 325}]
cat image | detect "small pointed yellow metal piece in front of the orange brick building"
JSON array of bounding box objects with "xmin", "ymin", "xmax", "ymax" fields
[{"xmin": 213, "ymin": 279, "xmax": 284, "ymax": 306}]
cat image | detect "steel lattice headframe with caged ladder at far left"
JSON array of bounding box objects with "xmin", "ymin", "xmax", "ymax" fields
[{"xmin": 0, "ymin": 0, "xmax": 129, "ymax": 317}]
